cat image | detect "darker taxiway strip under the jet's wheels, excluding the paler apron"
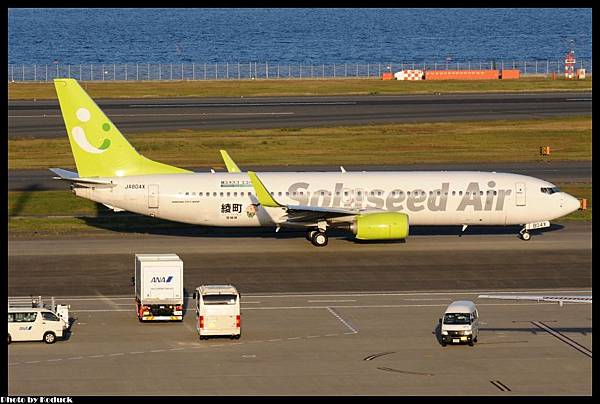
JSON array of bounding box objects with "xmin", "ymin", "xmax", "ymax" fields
[{"xmin": 8, "ymin": 222, "xmax": 592, "ymax": 296}]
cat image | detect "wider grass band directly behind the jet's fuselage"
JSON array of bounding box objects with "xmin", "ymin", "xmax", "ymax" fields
[{"xmin": 8, "ymin": 116, "xmax": 592, "ymax": 169}]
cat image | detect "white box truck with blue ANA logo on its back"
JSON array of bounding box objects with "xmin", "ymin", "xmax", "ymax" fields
[{"xmin": 134, "ymin": 254, "xmax": 183, "ymax": 321}]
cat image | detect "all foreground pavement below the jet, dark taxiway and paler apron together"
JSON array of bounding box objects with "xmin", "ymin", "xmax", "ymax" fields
[{"xmin": 8, "ymin": 218, "xmax": 592, "ymax": 396}]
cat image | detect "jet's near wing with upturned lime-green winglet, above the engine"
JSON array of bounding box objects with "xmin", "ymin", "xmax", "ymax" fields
[{"xmin": 248, "ymin": 171, "xmax": 362, "ymax": 223}]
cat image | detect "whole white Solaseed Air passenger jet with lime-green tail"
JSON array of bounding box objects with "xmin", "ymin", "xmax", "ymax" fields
[{"xmin": 51, "ymin": 79, "xmax": 579, "ymax": 246}]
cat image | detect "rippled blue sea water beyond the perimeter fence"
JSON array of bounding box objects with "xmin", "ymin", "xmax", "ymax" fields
[{"xmin": 8, "ymin": 8, "xmax": 592, "ymax": 65}]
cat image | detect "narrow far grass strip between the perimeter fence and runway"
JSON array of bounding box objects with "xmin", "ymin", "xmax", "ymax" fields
[{"xmin": 8, "ymin": 77, "xmax": 592, "ymax": 100}]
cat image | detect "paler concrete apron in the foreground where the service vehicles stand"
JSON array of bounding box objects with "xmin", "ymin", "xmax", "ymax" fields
[{"xmin": 8, "ymin": 290, "xmax": 592, "ymax": 396}]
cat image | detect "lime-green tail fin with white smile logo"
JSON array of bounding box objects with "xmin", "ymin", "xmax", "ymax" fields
[{"xmin": 54, "ymin": 79, "xmax": 190, "ymax": 177}]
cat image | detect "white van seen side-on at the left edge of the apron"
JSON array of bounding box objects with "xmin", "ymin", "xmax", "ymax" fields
[{"xmin": 8, "ymin": 307, "xmax": 67, "ymax": 344}]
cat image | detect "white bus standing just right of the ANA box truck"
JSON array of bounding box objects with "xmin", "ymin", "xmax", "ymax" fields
[{"xmin": 194, "ymin": 285, "xmax": 241, "ymax": 339}]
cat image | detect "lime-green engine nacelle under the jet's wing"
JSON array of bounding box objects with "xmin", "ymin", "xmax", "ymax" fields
[{"xmin": 352, "ymin": 212, "xmax": 409, "ymax": 240}]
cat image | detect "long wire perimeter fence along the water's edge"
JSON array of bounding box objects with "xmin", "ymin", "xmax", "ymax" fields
[{"xmin": 8, "ymin": 59, "xmax": 592, "ymax": 82}]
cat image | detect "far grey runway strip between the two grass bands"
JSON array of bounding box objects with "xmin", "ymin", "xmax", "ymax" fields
[{"xmin": 8, "ymin": 91, "xmax": 592, "ymax": 139}]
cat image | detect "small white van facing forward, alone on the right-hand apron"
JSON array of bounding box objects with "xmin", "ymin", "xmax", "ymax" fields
[{"xmin": 440, "ymin": 300, "xmax": 479, "ymax": 346}]
